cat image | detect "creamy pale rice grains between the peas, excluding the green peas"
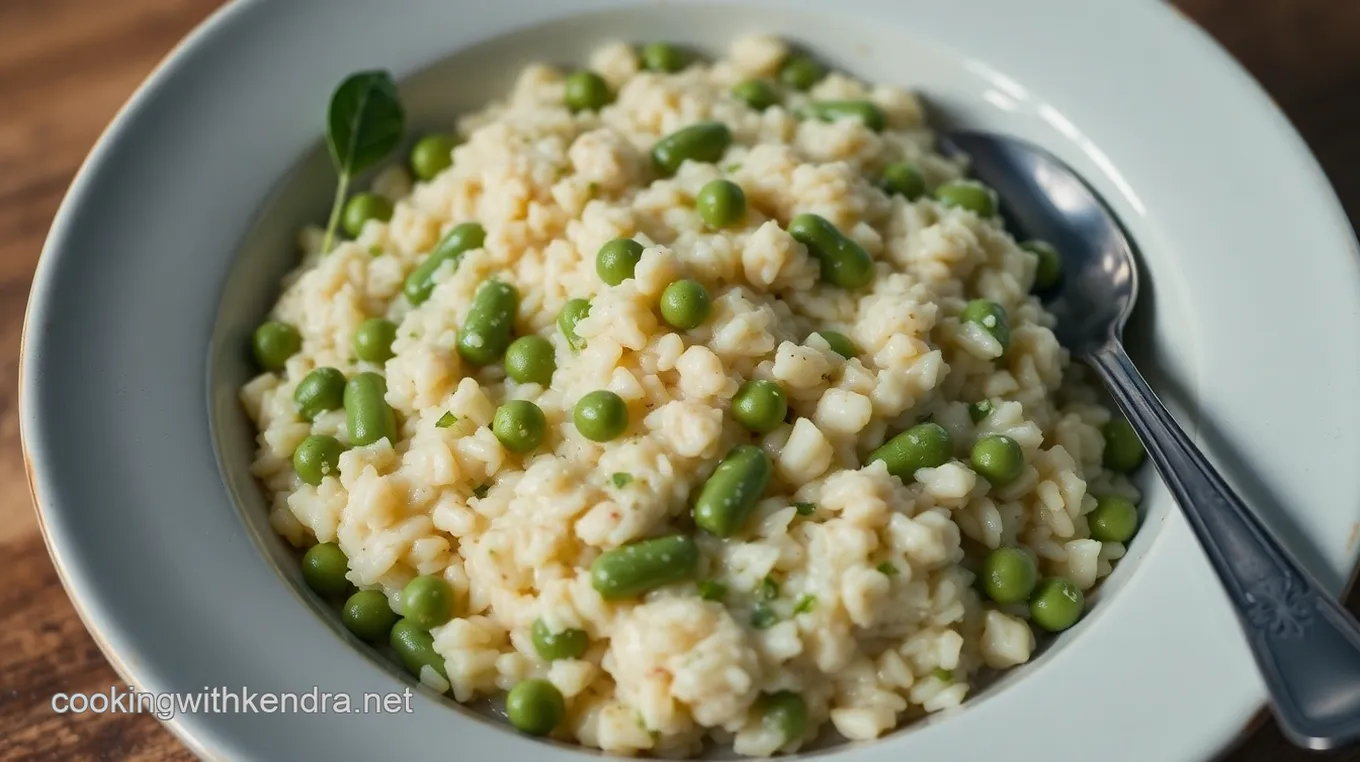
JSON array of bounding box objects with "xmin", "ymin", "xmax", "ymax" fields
[{"xmin": 241, "ymin": 37, "xmax": 1137, "ymax": 755}]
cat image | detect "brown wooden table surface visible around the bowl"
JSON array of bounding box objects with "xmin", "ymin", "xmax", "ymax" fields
[{"xmin": 0, "ymin": 0, "xmax": 1360, "ymax": 762}]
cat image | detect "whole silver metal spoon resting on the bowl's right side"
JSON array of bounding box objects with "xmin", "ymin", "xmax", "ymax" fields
[{"xmin": 944, "ymin": 132, "xmax": 1360, "ymax": 748}]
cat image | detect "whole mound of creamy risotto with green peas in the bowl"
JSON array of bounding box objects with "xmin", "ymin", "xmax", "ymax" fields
[{"xmin": 241, "ymin": 35, "xmax": 1142, "ymax": 757}]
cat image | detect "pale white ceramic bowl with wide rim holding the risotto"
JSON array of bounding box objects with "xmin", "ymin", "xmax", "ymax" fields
[{"xmin": 22, "ymin": 0, "xmax": 1360, "ymax": 762}]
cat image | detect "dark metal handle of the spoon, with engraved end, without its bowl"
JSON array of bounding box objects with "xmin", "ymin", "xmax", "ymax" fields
[{"xmin": 1087, "ymin": 342, "xmax": 1360, "ymax": 748}]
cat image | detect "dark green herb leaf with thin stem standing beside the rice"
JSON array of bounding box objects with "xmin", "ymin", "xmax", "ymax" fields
[{"xmin": 321, "ymin": 71, "xmax": 407, "ymax": 253}]
